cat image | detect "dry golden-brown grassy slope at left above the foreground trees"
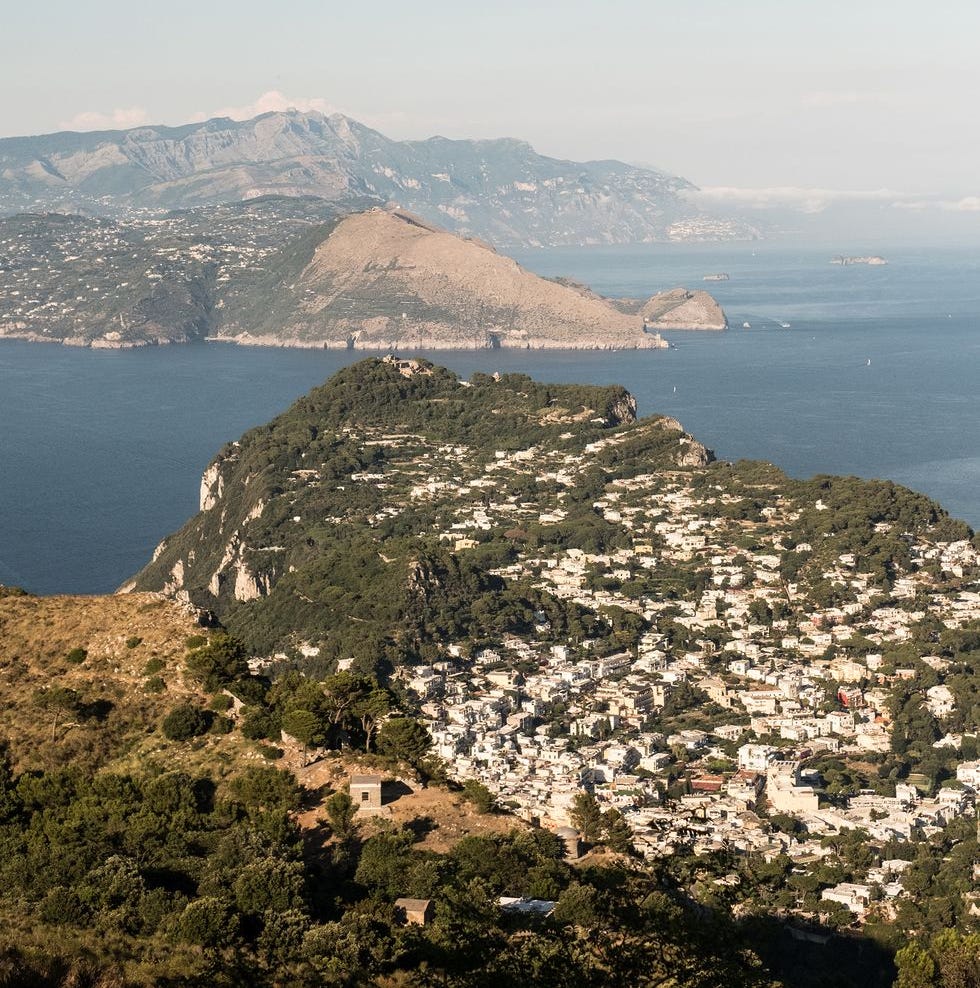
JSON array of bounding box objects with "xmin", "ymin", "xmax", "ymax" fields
[{"xmin": 0, "ymin": 592, "xmax": 526, "ymax": 851}]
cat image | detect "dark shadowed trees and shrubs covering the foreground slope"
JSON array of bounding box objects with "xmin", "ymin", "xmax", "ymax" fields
[{"xmin": 0, "ymin": 598, "xmax": 956, "ymax": 988}]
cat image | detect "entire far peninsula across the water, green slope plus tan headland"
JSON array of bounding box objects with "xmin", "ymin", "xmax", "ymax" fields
[{"xmin": 0, "ymin": 203, "xmax": 725, "ymax": 349}]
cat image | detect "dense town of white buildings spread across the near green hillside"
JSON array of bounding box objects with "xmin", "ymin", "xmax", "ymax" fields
[{"xmin": 324, "ymin": 404, "xmax": 980, "ymax": 918}]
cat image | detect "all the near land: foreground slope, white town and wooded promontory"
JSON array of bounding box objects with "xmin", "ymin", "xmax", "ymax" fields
[{"xmin": 0, "ymin": 357, "xmax": 980, "ymax": 988}]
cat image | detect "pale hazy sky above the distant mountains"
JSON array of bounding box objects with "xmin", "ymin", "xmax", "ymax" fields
[{"xmin": 0, "ymin": 0, "xmax": 980, "ymax": 225}]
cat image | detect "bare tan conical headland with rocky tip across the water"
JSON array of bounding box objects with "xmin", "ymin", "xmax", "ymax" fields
[{"xmin": 216, "ymin": 209, "xmax": 723, "ymax": 350}]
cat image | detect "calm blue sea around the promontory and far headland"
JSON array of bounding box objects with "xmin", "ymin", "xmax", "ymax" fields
[{"xmin": 0, "ymin": 244, "xmax": 980, "ymax": 593}]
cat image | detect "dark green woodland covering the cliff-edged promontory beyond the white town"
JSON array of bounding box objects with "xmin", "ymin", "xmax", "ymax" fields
[{"xmin": 130, "ymin": 360, "xmax": 681, "ymax": 660}]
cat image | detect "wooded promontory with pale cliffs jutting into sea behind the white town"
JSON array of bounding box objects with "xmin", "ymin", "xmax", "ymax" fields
[{"xmin": 121, "ymin": 355, "xmax": 714, "ymax": 643}]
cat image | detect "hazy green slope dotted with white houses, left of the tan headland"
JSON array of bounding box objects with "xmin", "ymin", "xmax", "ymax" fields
[{"xmin": 0, "ymin": 198, "xmax": 330, "ymax": 348}]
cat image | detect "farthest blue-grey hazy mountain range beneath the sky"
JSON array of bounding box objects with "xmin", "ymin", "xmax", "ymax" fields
[{"xmin": 0, "ymin": 110, "xmax": 755, "ymax": 247}]
